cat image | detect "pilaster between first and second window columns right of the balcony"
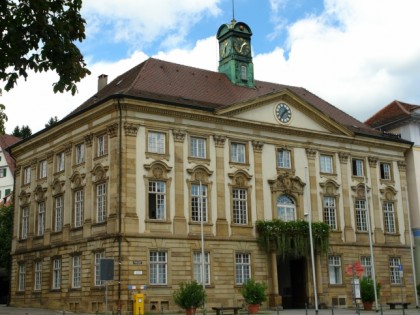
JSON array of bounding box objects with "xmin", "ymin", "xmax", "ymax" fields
[{"xmin": 338, "ymin": 153, "xmax": 356, "ymax": 243}]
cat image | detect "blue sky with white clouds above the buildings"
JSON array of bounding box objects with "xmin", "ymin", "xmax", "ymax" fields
[{"xmin": 0, "ymin": 0, "xmax": 420, "ymax": 133}]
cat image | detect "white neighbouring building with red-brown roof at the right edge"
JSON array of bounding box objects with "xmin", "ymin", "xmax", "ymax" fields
[{"xmin": 366, "ymin": 100, "xmax": 420, "ymax": 283}]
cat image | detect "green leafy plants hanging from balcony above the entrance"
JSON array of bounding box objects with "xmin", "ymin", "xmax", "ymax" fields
[{"xmin": 256, "ymin": 219, "xmax": 330, "ymax": 257}]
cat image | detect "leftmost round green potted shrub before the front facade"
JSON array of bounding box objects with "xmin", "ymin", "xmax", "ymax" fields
[{"xmin": 173, "ymin": 281, "xmax": 206, "ymax": 314}]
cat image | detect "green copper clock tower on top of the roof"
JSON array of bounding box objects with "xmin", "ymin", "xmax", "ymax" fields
[{"xmin": 217, "ymin": 20, "xmax": 254, "ymax": 87}]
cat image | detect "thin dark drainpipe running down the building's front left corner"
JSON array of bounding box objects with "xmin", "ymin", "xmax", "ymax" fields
[{"xmin": 117, "ymin": 97, "xmax": 122, "ymax": 315}]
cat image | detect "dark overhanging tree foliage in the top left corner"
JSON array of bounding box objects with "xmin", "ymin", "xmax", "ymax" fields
[{"xmin": 0, "ymin": 0, "xmax": 90, "ymax": 94}]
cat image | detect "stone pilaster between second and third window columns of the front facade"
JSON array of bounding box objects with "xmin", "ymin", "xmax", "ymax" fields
[{"xmin": 213, "ymin": 135, "xmax": 229, "ymax": 236}]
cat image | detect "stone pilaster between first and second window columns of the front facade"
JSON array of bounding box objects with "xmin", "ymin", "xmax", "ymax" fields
[{"xmin": 172, "ymin": 130, "xmax": 188, "ymax": 235}]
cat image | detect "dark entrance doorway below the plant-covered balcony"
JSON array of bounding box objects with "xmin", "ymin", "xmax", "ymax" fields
[{"xmin": 277, "ymin": 256, "xmax": 307, "ymax": 309}]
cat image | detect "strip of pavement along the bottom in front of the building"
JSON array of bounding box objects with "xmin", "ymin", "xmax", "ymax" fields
[{"xmin": 0, "ymin": 305, "xmax": 420, "ymax": 315}]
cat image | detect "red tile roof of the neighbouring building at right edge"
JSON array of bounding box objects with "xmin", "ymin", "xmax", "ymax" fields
[{"xmin": 365, "ymin": 100, "xmax": 420, "ymax": 128}]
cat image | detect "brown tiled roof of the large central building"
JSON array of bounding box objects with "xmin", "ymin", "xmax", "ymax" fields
[{"xmin": 69, "ymin": 58, "xmax": 404, "ymax": 142}]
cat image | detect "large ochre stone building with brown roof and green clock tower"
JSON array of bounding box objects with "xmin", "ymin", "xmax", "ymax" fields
[{"xmin": 11, "ymin": 21, "xmax": 415, "ymax": 312}]
